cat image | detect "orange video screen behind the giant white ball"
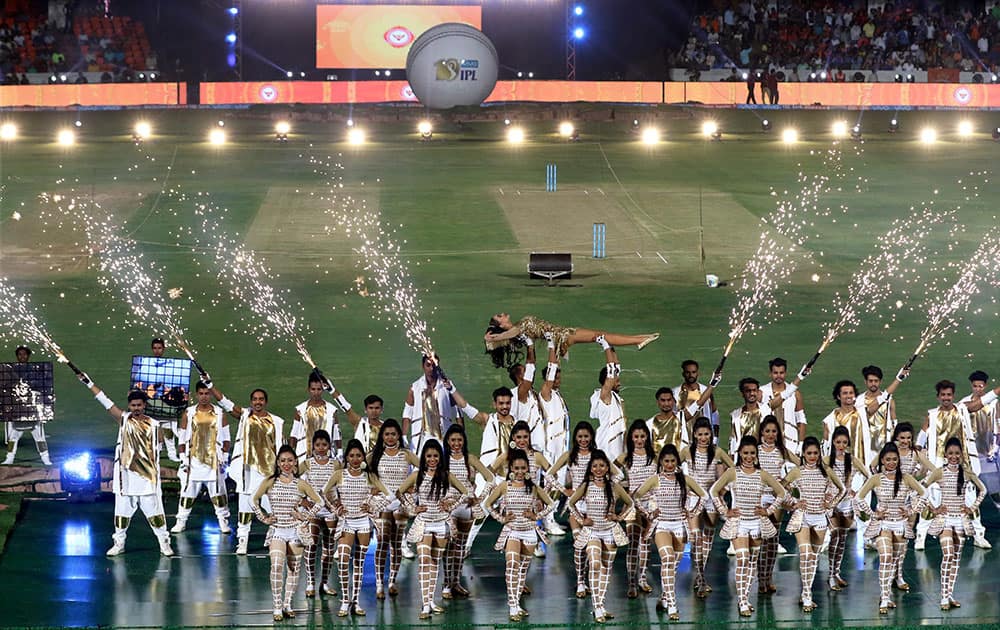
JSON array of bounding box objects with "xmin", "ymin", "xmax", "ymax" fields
[{"xmin": 316, "ymin": 4, "xmax": 483, "ymax": 70}]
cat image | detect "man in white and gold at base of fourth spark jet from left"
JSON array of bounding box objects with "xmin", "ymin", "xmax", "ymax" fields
[{"xmin": 402, "ymin": 354, "xmax": 461, "ymax": 453}]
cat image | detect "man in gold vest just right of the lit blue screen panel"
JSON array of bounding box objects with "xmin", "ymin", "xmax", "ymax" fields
[{"xmin": 170, "ymin": 381, "xmax": 231, "ymax": 534}]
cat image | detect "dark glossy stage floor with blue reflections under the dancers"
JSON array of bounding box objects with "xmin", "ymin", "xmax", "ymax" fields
[{"xmin": 0, "ymin": 498, "xmax": 1000, "ymax": 628}]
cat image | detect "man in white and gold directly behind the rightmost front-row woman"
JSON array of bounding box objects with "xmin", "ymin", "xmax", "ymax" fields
[{"xmin": 913, "ymin": 380, "xmax": 1000, "ymax": 551}]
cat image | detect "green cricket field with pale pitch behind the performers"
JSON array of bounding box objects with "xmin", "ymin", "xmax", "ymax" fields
[{"xmin": 0, "ymin": 107, "xmax": 1000, "ymax": 458}]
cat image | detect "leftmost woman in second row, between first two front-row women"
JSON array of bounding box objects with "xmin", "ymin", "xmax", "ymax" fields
[{"xmin": 299, "ymin": 429, "xmax": 340, "ymax": 597}]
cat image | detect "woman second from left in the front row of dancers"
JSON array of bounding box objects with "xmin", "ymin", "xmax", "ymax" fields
[{"xmin": 323, "ymin": 439, "xmax": 392, "ymax": 617}]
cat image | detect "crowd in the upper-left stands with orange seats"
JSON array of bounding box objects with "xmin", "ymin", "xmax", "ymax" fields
[{"xmin": 0, "ymin": 0, "xmax": 157, "ymax": 85}]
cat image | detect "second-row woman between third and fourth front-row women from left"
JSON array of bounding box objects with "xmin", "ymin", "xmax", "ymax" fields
[{"xmin": 441, "ymin": 424, "xmax": 493, "ymax": 599}]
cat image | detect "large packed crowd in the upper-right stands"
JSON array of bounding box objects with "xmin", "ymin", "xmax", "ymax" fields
[{"xmin": 668, "ymin": 0, "xmax": 1000, "ymax": 78}]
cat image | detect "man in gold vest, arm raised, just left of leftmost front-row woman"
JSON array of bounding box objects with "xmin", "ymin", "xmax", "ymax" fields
[{"xmin": 214, "ymin": 382, "xmax": 285, "ymax": 556}]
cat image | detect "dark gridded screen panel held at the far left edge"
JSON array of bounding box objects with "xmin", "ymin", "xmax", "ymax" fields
[{"xmin": 0, "ymin": 362, "xmax": 56, "ymax": 431}]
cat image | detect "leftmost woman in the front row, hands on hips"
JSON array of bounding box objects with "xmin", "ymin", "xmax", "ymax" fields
[{"xmin": 251, "ymin": 444, "xmax": 325, "ymax": 621}]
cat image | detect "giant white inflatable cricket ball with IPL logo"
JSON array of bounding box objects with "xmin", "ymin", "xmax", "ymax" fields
[{"xmin": 406, "ymin": 23, "xmax": 499, "ymax": 109}]
